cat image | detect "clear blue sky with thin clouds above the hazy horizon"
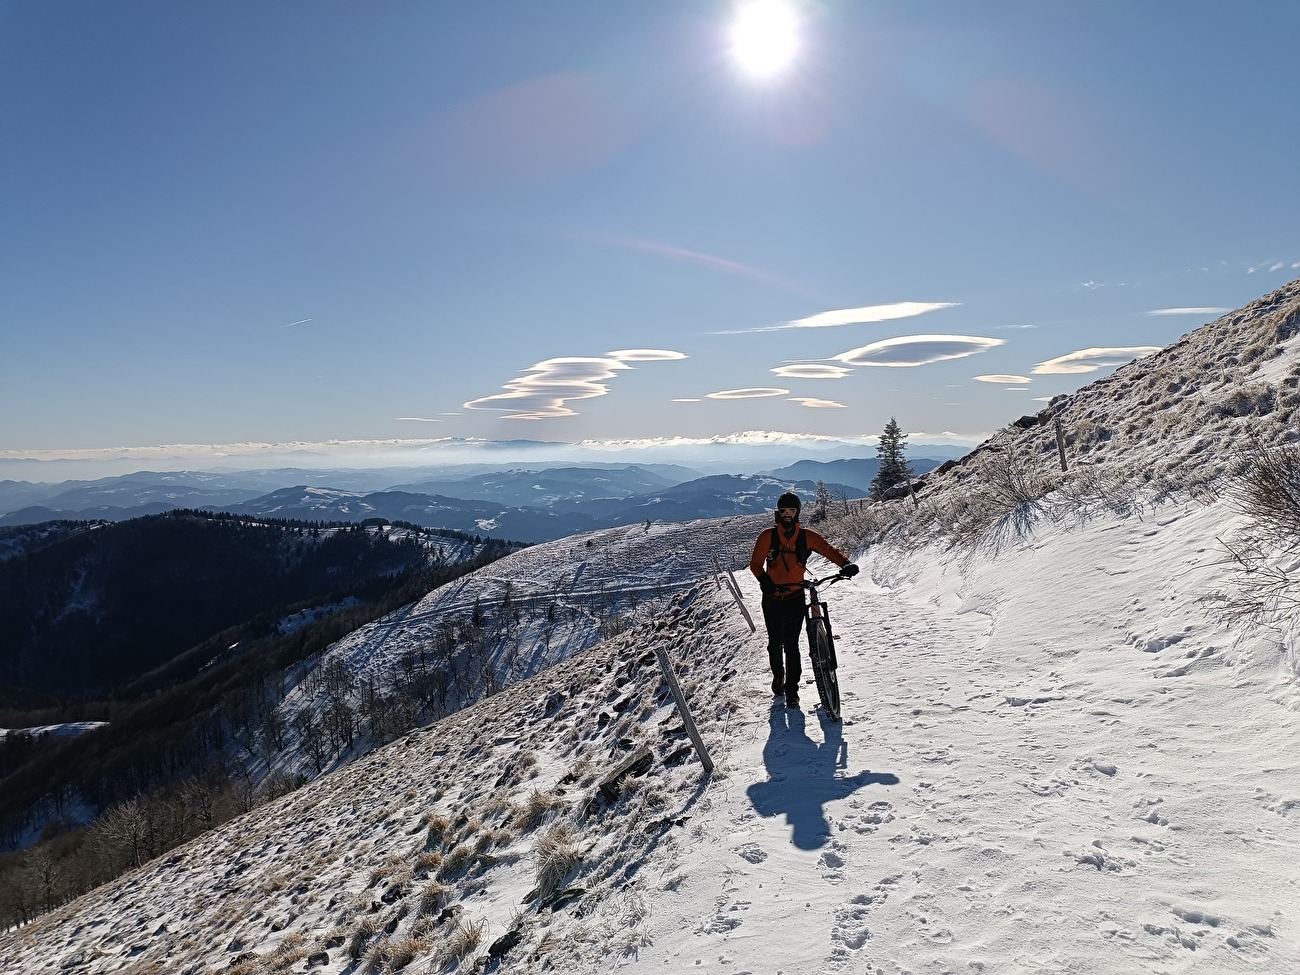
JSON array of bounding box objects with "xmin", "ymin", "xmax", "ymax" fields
[{"xmin": 0, "ymin": 0, "xmax": 1300, "ymax": 470}]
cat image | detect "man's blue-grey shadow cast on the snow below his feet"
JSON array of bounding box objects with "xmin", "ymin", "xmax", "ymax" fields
[{"xmin": 746, "ymin": 699, "xmax": 898, "ymax": 850}]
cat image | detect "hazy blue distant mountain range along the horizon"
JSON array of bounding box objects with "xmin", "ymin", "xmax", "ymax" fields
[{"xmin": 0, "ymin": 458, "xmax": 956, "ymax": 542}]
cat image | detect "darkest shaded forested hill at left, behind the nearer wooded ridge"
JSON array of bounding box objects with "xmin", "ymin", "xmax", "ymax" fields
[{"xmin": 0, "ymin": 511, "xmax": 512, "ymax": 697}]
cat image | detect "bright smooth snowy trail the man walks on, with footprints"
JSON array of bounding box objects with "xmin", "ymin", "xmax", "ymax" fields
[{"xmin": 629, "ymin": 506, "xmax": 1300, "ymax": 975}]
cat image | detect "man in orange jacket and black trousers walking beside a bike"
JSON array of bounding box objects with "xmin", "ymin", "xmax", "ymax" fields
[{"xmin": 749, "ymin": 491, "xmax": 858, "ymax": 707}]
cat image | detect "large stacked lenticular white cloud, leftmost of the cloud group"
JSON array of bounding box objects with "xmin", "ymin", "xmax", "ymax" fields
[{"xmin": 462, "ymin": 348, "xmax": 686, "ymax": 420}]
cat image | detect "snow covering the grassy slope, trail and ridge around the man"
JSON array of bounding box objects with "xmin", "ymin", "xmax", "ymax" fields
[{"xmin": 0, "ymin": 282, "xmax": 1300, "ymax": 975}]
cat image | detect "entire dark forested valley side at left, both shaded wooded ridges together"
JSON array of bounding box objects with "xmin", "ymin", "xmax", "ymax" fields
[{"xmin": 0, "ymin": 511, "xmax": 527, "ymax": 845}]
